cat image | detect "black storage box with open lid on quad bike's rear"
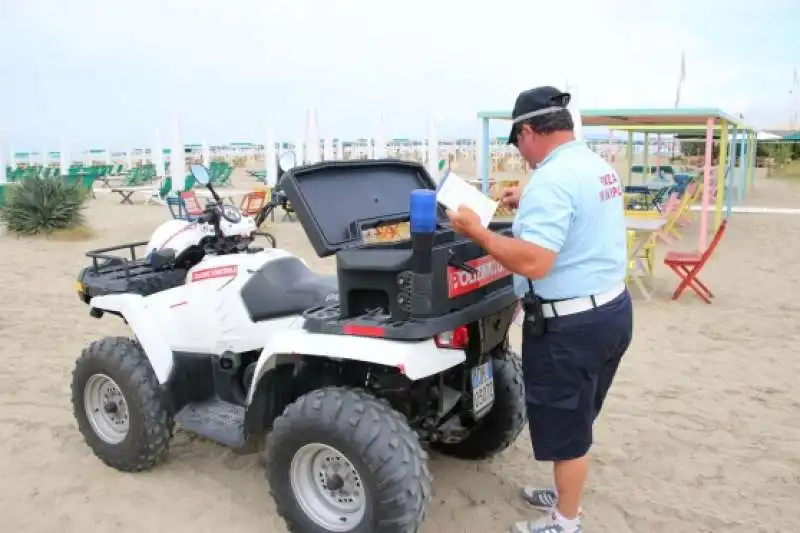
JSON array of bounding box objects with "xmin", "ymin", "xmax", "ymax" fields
[{"xmin": 280, "ymin": 159, "xmax": 516, "ymax": 337}]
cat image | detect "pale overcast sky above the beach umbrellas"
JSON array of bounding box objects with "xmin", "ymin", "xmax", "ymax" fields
[{"xmin": 0, "ymin": 0, "xmax": 800, "ymax": 150}]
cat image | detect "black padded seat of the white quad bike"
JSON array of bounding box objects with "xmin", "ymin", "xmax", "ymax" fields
[{"xmin": 241, "ymin": 257, "xmax": 339, "ymax": 322}]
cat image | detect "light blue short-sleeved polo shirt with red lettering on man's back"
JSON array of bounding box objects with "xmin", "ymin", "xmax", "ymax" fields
[{"xmin": 512, "ymin": 141, "xmax": 628, "ymax": 300}]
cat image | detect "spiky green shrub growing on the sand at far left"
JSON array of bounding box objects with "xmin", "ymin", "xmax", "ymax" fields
[{"xmin": 0, "ymin": 177, "xmax": 89, "ymax": 235}]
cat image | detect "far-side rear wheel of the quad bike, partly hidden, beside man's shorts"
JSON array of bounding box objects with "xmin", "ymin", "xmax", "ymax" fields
[{"xmin": 432, "ymin": 351, "xmax": 526, "ymax": 460}]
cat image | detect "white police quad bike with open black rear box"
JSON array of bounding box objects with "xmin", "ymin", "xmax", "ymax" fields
[{"xmin": 72, "ymin": 160, "xmax": 525, "ymax": 533}]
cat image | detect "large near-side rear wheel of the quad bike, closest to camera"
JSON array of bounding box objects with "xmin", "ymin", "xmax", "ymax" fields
[{"xmin": 266, "ymin": 387, "xmax": 431, "ymax": 533}]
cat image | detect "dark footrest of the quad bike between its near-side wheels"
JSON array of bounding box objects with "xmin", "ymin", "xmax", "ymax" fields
[{"xmin": 175, "ymin": 398, "xmax": 245, "ymax": 448}]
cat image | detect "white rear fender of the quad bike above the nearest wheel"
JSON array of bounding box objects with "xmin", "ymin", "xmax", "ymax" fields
[{"xmin": 247, "ymin": 329, "xmax": 466, "ymax": 404}]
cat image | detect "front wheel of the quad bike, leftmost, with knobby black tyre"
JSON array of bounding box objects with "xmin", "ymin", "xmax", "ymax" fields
[{"xmin": 72, "ymin": 337, "xmax": 173, "ymax": 472}]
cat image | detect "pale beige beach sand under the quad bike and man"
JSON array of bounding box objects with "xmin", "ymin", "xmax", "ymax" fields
[{"xmin": 0, "ymin": 167, "xmax": 800, "ymax": 533}]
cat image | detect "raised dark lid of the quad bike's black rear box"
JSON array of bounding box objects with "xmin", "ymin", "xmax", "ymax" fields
[{"xmin": 280, "ymin": 159, "xmax": 447, "ymax": 257}]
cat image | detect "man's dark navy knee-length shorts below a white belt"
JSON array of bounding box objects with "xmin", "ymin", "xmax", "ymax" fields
[{"xmin": 522, "ymin": 290, "xmax": 633, "ymax": 461}]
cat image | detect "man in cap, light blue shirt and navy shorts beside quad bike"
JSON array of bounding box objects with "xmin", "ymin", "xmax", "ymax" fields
[{"xmin": 448, "ymin": 87, "xmax": 633, "ymax": 533}]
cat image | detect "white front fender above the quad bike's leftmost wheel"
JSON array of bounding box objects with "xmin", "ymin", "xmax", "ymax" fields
[{"xmin": 89, "ymin": 294, "xmax": 174, "ymax": 384}]
